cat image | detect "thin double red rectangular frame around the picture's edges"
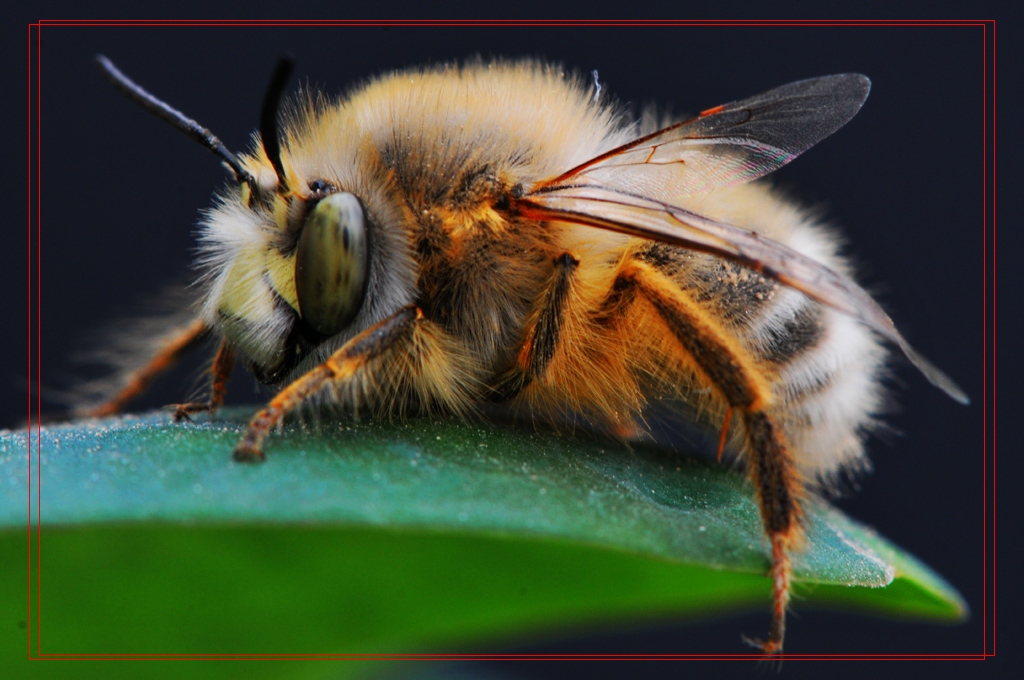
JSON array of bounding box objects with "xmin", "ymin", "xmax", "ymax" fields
[{"xmin": 26, "ymin": 19, "xmax": 997, "ymax": 661}]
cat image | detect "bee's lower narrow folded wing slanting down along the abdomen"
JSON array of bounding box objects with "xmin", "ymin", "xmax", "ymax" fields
[{"xmin": 517, "ymin": 184, "xmax": 969, "ymax": 403}]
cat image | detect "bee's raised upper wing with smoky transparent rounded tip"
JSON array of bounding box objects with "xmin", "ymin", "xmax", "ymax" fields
[{"xmin": 532, "ymin": 74, "xmax": 871, "ymax": 197}]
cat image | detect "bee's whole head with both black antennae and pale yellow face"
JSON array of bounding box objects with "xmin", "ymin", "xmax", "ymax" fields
[{"xmin": 97, "ymin": 55, "xmax": 380, "ymax": 383}]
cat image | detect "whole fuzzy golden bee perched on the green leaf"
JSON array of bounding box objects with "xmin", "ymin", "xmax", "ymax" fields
[{"xmin": 91, "ymin": 57, "xmax": 968, "ymax": 653}]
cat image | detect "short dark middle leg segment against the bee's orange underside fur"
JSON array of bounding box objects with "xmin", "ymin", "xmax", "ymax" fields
[{"xmin": 492, "ymin": 253, "xmax": 580, "ymax": 401}]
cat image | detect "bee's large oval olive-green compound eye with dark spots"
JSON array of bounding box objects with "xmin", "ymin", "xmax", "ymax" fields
[{"xmin": 295, "ymin": 192, "xmax": 370, "ymax": 335}]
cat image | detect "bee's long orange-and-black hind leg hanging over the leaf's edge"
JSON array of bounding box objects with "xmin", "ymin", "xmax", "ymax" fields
[{"xmin": 616, "ymin": 261, "xmax": 803, "ymax": 654}]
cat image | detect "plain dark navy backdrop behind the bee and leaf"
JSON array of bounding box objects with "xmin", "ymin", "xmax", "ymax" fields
[{"xmin": 0, "ymin": 15, "xmax": 1003, "ymax": 677}]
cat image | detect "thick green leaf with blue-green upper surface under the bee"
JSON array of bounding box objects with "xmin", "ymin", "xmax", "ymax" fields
[{"xmin": 0, "ymin": 410, "xmax": 967, "ymax": 677}]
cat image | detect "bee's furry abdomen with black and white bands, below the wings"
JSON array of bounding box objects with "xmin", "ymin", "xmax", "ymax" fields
[{"xmin": 638, "ymin": 238, "xmax": 885, "ymax": 483}]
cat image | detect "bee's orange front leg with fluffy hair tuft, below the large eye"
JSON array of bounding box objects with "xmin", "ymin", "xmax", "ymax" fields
[{"xmin": 234, "ymin": 305, "xmax": 478, "ymax": 462}]
